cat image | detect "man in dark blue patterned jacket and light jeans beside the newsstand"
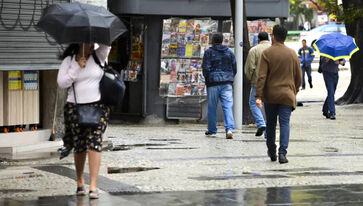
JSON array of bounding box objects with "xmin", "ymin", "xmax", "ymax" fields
[{"xmin": 202, "ymin": 33, "xmax": 237, "ymax": 139}]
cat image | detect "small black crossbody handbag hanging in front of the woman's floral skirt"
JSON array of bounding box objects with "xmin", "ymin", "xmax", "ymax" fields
[{"xmin": 72, "ymin": 83, "xmax": 104, "ymax": 128}]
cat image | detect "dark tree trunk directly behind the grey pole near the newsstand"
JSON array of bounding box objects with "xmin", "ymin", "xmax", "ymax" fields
[{"xmin": 230, "ymin": 0, "xmax": 255, "ymax": 124}]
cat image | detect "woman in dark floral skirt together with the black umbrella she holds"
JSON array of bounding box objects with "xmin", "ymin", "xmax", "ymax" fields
[{"xmin": 37, "ymin": 2, "xmax": 127, "ymax": 198}]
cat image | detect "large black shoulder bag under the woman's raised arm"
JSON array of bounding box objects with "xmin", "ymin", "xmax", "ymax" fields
[{"xmin": 93, "ymin": 53, "xmax": 126, "ymax": 106}]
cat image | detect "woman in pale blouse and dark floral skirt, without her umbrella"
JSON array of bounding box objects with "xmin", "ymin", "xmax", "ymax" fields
[{"xmin": 57, "ymin": 44, "xmax": 111, "ymax": 199}]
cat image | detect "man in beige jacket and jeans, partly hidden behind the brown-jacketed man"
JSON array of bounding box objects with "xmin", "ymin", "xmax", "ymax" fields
[{"xmin": 245, "ymin": 32, "xmax": 270, "ymax": 136}]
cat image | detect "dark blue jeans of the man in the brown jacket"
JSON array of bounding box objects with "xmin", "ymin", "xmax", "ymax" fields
[{"xmin": 265, "ymin": 103, "xmax": 292, "ymax": 155}]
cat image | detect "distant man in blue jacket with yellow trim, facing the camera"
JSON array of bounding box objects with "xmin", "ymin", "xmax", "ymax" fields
[{"xmin": 297, "ymin": 39, "xmax": 315, "ymax": 89}]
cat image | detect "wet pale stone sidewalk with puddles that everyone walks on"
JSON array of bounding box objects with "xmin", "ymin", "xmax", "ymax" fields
[{"xmin": 0, "ymin": 69, "xmax": 363, "ymax": 205}]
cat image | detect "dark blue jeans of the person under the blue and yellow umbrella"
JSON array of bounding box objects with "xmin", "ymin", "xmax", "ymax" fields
[{"xmin": 323, "ymin": 72, "xmax": 339, "ymax": 115}]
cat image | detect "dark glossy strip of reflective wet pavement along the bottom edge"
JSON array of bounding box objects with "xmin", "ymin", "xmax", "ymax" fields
[{"xmin": 0, "ymin": 185, "xmax": 363, "ymax": 206}]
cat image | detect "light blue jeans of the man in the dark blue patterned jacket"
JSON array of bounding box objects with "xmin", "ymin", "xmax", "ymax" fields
[{"xmin": 207, "ymin": 84, "xmax": 234, "ymax": 134}]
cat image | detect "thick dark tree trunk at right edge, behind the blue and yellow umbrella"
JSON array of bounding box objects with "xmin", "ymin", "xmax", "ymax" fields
[{"xmin": 336, "ymin": 0, "xmax": 363, "ymax": 105}]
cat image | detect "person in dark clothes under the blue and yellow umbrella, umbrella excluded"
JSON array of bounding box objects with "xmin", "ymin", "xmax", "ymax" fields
[{"xmin": 319, "ymin": 56, "xmax": 345, "ymax": 120}]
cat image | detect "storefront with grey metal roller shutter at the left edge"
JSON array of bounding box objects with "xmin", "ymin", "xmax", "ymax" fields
[{"xmin": 0, "ymin": 0, "xmax": 68, "ymax": 153}]
